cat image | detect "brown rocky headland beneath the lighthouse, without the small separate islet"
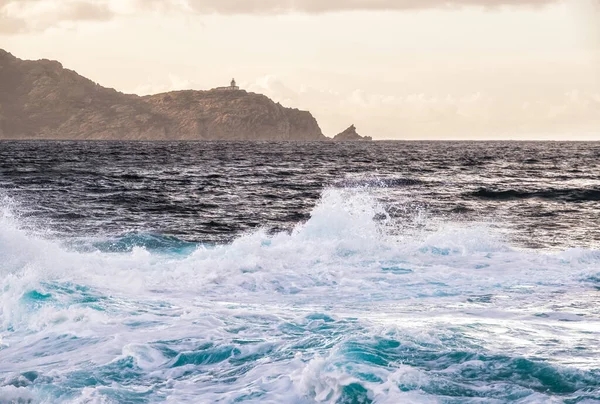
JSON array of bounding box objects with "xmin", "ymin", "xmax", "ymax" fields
[{"xmin": 0, "ymin": 49, "xmax": 327, "ymax": 140}]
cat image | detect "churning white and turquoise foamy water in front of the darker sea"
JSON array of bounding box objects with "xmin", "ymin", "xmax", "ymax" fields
[{"xmin": 0, "ymin": 189, "xmax": 600, "ymax": 403}]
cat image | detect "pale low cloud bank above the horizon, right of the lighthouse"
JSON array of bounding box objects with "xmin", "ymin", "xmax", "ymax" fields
[{"xmin": 242, "ymin": 75, "xmax": 600, "ymax": 139}]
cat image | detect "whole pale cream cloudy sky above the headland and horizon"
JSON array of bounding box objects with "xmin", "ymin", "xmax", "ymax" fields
[{"xmin": 0, "ymin": 0, "xmax": 600, "ymax": 140}]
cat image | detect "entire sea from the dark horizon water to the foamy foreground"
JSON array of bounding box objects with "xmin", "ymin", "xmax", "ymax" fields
[{"xmin": 0, "ymin": 141, "xmax": 600, "ymax": 404}]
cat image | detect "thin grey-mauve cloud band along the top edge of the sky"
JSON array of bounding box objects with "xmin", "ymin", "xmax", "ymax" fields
[{"xmin": 0, "ymin": 0, "xmax": 564, "ymax": 34}]
